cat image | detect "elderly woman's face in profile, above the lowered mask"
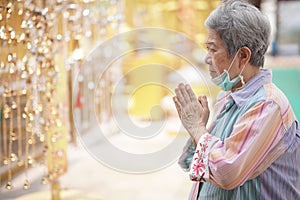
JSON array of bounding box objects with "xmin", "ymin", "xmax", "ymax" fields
[{"xmin": 205, "ymin": 29, "xmax": 239, "ymax": 79}]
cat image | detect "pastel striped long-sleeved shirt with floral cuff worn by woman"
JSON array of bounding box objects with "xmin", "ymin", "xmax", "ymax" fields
[{"xmin": 179, "ymin": 69, "xmax": 300, "ymax": 200}]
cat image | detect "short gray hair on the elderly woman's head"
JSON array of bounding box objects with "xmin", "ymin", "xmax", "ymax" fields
[{"xmin": 205, "ymin": 0, "xmax": 271, "ymax": 67}]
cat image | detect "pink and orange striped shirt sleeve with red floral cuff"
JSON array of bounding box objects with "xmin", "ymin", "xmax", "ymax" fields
[{"xmin": 190, "ymin": 101, "xmax": 286, "ymax": 189}]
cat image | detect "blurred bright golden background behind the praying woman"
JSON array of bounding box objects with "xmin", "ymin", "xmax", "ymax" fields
[{"xmin": 0, "ymin": 0, "xmax": 300, "ymax": 200}]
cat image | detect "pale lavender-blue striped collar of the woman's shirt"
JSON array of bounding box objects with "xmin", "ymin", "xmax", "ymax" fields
[{"xmin": 229, "ymin": 69, "xmax": 272, "ymax": 107}]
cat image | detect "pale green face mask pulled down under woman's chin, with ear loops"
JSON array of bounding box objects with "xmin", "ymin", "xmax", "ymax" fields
[{"xmin": 212, "ymin": 51, "xmax": 245, "ymax": 91}]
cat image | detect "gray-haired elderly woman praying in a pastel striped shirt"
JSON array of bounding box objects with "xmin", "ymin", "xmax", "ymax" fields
[{"xmin": 173, "ymin": 1, "xmax": 300, "ymax": 200}]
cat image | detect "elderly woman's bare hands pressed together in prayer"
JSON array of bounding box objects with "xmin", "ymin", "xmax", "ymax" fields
[{"xmin": 173, "ymin": 83, "xmax": 210, "ymax": 145}]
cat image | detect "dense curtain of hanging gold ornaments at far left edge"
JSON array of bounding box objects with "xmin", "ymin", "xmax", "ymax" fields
[{"xmin": 0, "ymin": 0, "xmax": 66, "ymax": 189}]
